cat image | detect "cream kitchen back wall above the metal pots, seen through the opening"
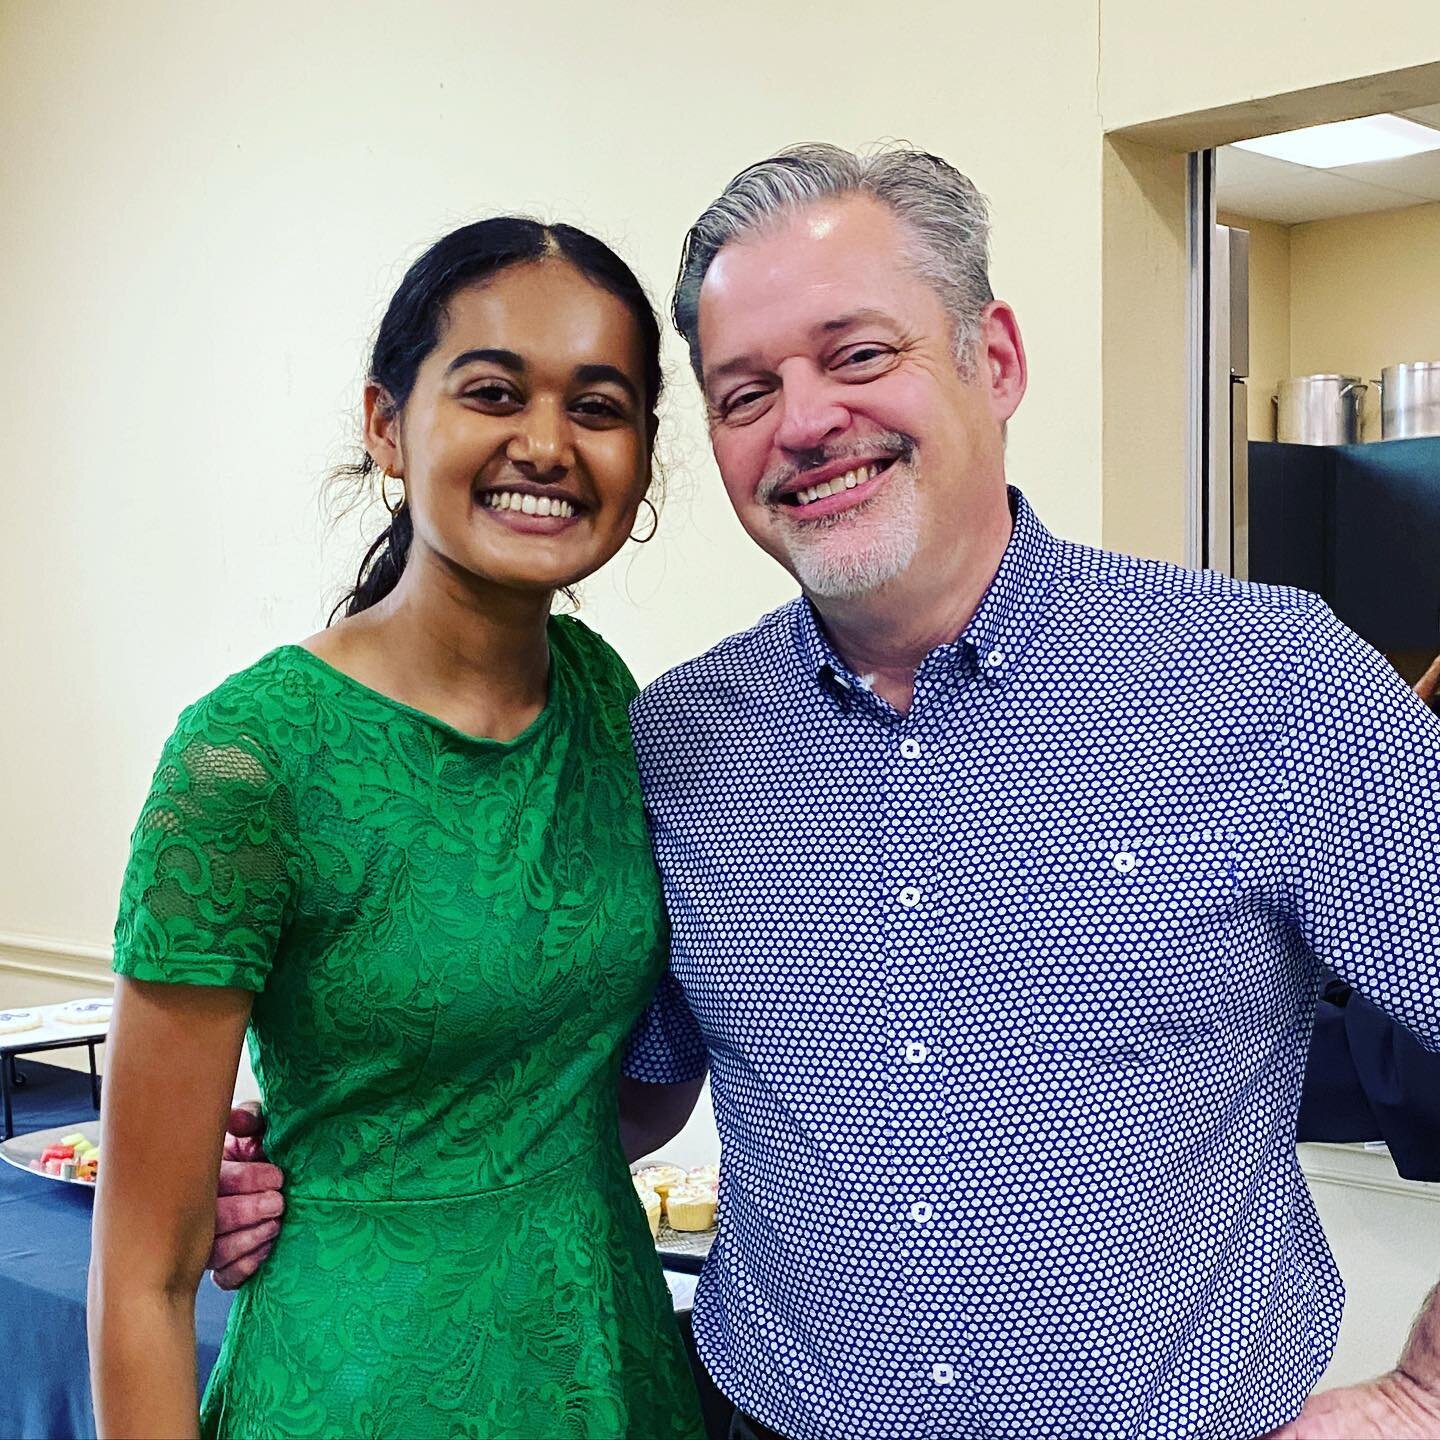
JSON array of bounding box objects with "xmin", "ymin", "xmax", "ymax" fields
[{"xmin": 1290, "ymin": 204, "xmax": 1440, "ymax": 439}]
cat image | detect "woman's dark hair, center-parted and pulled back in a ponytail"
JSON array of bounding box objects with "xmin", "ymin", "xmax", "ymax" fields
[{"xmin": 330, "ymin": 215, "xmax": 664, "ymax": 622}]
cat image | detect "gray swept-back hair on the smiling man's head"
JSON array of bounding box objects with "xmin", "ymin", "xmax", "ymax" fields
[{"xmin": 671, "ymin": 143, "xmax": 995, "ymax": 380}]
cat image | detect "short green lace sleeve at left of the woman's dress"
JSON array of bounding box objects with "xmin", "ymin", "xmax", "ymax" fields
[{"xmin": 115, "ymin": 701, "xmax": 297, "ymax": 991}]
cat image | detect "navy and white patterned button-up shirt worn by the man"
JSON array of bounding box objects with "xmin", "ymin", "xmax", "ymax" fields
[{"xmin": 626, "ymin": 491, "xmax": 1440, "ymax": 1440}]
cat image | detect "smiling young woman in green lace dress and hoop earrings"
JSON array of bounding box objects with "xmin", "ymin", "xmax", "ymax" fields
[{"xmin": 89, "ymin": 219, "xmax": 701, "ymax": 1440}]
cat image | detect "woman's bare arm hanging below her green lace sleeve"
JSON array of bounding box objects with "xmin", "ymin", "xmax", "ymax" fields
[{"xmin": 89, "ymin": 978, "xmax": 253, "ymax": 1440}]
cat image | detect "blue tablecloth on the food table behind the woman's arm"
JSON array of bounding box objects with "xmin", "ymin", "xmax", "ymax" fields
[{"xmin": 0, "ymin": 1058, "xmax": 232, "ymax": 1440}]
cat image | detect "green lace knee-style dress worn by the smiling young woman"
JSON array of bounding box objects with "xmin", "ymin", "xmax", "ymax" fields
[{"xmin": 115, "ymin": 619, "xmax": 703, "ymax": 1440}]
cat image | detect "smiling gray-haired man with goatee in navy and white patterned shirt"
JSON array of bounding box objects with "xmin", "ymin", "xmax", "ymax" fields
[{"xmin": 625, "ymin": 145, "xmax": 1440, "ymax": 1440}]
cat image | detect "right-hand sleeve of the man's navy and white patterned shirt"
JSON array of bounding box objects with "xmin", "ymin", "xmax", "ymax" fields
[{"xmin": 1283, "ymin": 606, "xmax": 1440, "ymax": 1050}]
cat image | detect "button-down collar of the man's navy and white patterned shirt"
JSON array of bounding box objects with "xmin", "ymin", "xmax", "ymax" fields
[{"xmin": 795, "ymin": 485, "xmax": 1061, "ymax": 703}]
